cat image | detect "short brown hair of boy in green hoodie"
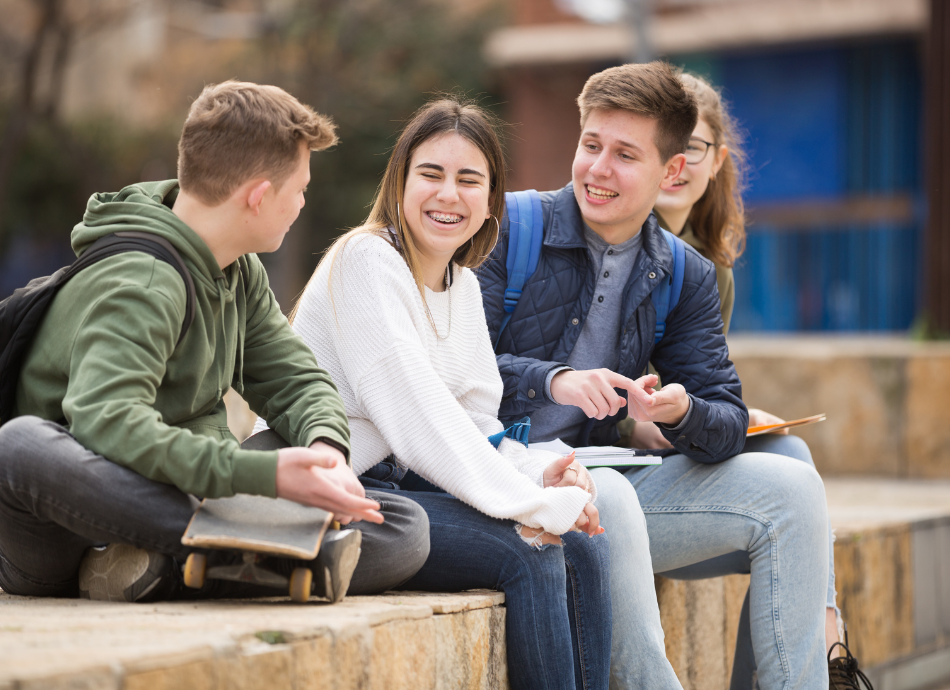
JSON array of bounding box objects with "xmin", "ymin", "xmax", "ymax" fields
[{"xmin": 178, "ymin": 80, "xmax": 337, "ymax": 206}]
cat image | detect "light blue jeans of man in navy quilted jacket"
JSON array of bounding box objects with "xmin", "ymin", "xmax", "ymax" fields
[{"xmin": 593, "ymin": 441, "xmax": 834, "ymax": 690}]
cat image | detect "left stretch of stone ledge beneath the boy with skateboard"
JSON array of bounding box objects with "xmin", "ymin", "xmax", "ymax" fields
[{"xmin": 0, "ymin": 591, "xmax": 507, "ymax": 690}]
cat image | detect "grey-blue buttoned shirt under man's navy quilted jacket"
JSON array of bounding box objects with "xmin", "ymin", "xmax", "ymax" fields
[{"xmin": 531, "ymin": 225, "xmax": 643, "ymax": 443}]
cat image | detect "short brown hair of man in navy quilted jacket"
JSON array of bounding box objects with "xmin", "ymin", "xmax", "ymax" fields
[{"xmin": 577, "ymin": 60, "xmax": 698, "ymax": 161}]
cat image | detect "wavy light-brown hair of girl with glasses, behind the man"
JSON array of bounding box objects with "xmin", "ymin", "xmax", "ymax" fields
[{"xmin": 680, "ymin": 73, "xmax": 746, "ymax": 267}]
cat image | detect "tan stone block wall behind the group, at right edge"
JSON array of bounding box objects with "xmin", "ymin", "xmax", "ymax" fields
[{"xmin": 729, "ymin": 336, "xmax": 950, "ymax": 478}]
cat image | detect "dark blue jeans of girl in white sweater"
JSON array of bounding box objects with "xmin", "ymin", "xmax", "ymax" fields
[{"xmin": 360, "ymin": 463, "xmax": 611, "ymax": 690}]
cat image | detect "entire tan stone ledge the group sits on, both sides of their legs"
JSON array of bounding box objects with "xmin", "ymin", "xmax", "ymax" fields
[{"xmin": 0, "ymin": 478, "xmax": 950, "ymax": 690}]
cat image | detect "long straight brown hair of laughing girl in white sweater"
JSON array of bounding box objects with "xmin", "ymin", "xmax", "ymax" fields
[{"xmin": 290, "ymin": 96, "xmax": 506, "ymax": 322}]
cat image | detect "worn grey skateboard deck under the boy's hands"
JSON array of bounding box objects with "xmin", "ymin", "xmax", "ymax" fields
[{"xmin": 181, "ymin": 494, "xmax": 333, "ymax": 560}]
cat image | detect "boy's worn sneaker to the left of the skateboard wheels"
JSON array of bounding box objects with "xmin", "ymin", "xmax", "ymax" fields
[{"xmin": 79, "ymin": 544, "xmax": 174, "ymax": 601}]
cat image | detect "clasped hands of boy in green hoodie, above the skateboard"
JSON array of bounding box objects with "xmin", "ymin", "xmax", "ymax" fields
[{"xmin": 277, "ymin": 441, "xmax": 383, "ymax": 525}]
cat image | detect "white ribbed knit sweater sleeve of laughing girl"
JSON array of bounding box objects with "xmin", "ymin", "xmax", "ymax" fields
[{"xmin": 294, "ymin": 236, "xmax": 590, "ymax": 534}]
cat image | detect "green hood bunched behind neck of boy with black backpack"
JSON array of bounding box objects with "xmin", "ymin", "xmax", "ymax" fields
[{"xmin": 70, "ymin": 180, "xmax": 235, "ymax": 289}]
